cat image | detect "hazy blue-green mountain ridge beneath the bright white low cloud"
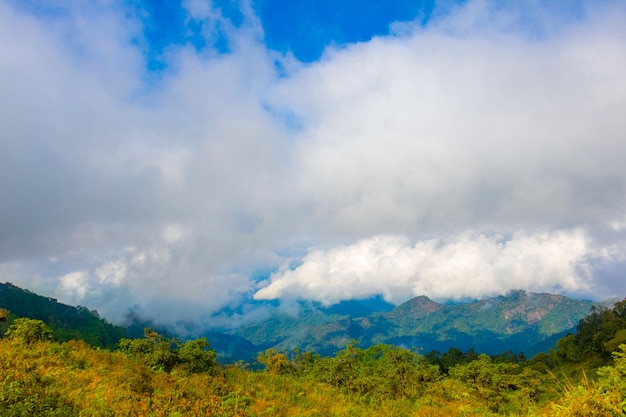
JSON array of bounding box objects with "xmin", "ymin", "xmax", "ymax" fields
[{"xmin": 225, "ymin": 291, "xmax": 594, "ymax": 356}]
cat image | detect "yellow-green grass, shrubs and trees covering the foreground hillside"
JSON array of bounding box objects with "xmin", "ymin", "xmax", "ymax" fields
[{"xmin": 0, "ymin": 300, "xmax": 626, "ymax": 417}]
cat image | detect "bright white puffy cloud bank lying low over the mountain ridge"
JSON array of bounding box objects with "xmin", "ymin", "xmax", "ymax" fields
[{"xmin": 255, "ymin": 231, "xmax": 591, "ymax": 304}]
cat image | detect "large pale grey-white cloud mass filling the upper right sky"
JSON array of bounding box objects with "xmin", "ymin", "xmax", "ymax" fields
[{"xmin": 282, "ymin": 5, "xmax": 626, "ymax": 237}]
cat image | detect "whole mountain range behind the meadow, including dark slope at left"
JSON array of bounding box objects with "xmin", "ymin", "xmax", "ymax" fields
[{"xmin": 0, "ymin": 283, "xmax": 616, "ymax": 362}]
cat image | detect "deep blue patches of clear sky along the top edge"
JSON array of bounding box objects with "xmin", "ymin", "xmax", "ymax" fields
[{"xmin": 135, "ymin": 0, "xmax": 434, "ymax": 62}]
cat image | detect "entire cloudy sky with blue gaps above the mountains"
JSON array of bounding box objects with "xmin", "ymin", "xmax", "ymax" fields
[{"xmin": 0, "ymin": 0, "xmax": 626, "ymax": 325}]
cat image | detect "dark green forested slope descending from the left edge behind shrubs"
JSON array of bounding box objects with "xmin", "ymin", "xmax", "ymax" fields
[{"xmin": 0, "ymin": 283, "xmax": 128, "ymax": 348}]
